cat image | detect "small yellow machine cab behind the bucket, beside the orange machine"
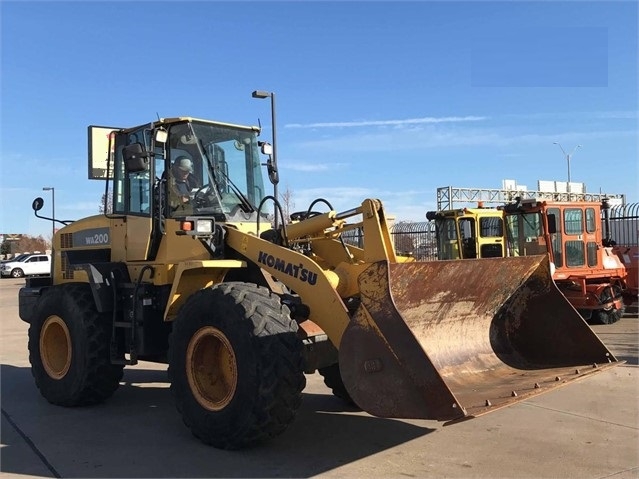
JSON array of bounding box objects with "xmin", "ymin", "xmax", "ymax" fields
[{"xmin": 427, "ymin": 208, "xmax": 505, "ymax": 260}]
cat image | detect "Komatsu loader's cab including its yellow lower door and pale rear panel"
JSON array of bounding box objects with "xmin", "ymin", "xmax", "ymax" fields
[{"xmin": 89, "ymin": 117, "xmax": 269, "ymax": 261}]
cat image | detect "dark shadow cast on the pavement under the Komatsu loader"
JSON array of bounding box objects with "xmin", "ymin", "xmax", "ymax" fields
[{"xmin": 0, "ymin": 365, "xmax": 436, "ymax": 477}]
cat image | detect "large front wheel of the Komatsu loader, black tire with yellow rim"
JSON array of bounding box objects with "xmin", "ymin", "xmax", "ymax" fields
[{"xmin": 169, "ymin": 282, "xmax": 306, "ymax": 449}]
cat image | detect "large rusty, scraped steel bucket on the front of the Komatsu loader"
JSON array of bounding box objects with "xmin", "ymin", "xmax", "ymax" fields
[{"xmin": 339, "ymin": 255, "xmax": 619, "ymax": 422}]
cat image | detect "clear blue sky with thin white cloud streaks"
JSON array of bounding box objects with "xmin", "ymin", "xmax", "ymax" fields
[{"xmin": 0, "ymin": 0, "xmax": 639, "ymax": 238}]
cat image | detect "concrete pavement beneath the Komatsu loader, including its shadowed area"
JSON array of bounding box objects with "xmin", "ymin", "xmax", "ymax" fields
[{"xmin": 0, "ymin": 279, "xmax": 639, "ymax": 479}]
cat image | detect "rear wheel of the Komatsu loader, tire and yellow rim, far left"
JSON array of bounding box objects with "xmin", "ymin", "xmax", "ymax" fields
[{"xmin": 29, "ymin": 283, "xmax": 124, "ymax": 406}]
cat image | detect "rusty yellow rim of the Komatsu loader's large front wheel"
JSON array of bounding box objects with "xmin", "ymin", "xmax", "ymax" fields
[{"xmin": 186, "ymin": 326, "xmax": 237, "ymax": 411}]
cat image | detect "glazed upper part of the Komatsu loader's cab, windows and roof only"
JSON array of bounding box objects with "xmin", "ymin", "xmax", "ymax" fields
[{"xmin": 113, "ymin": 118, "xmax": 265, "ymax": 222}]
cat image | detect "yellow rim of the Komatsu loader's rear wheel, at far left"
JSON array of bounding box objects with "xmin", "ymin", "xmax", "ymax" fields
[{"xmin": 40, "ymin": 316, "xmax": 71, "ymax": 379}]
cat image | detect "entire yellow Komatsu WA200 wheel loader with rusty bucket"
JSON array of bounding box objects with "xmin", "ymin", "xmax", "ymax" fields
[{"xmin": 19, "ymin": 117, "xmax": 618, "ymax": 449}]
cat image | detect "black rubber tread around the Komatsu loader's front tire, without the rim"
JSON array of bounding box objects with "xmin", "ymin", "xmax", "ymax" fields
[{"xmin": 169, "ymin": 282, "xmax": 306, "ymax": 449}]
